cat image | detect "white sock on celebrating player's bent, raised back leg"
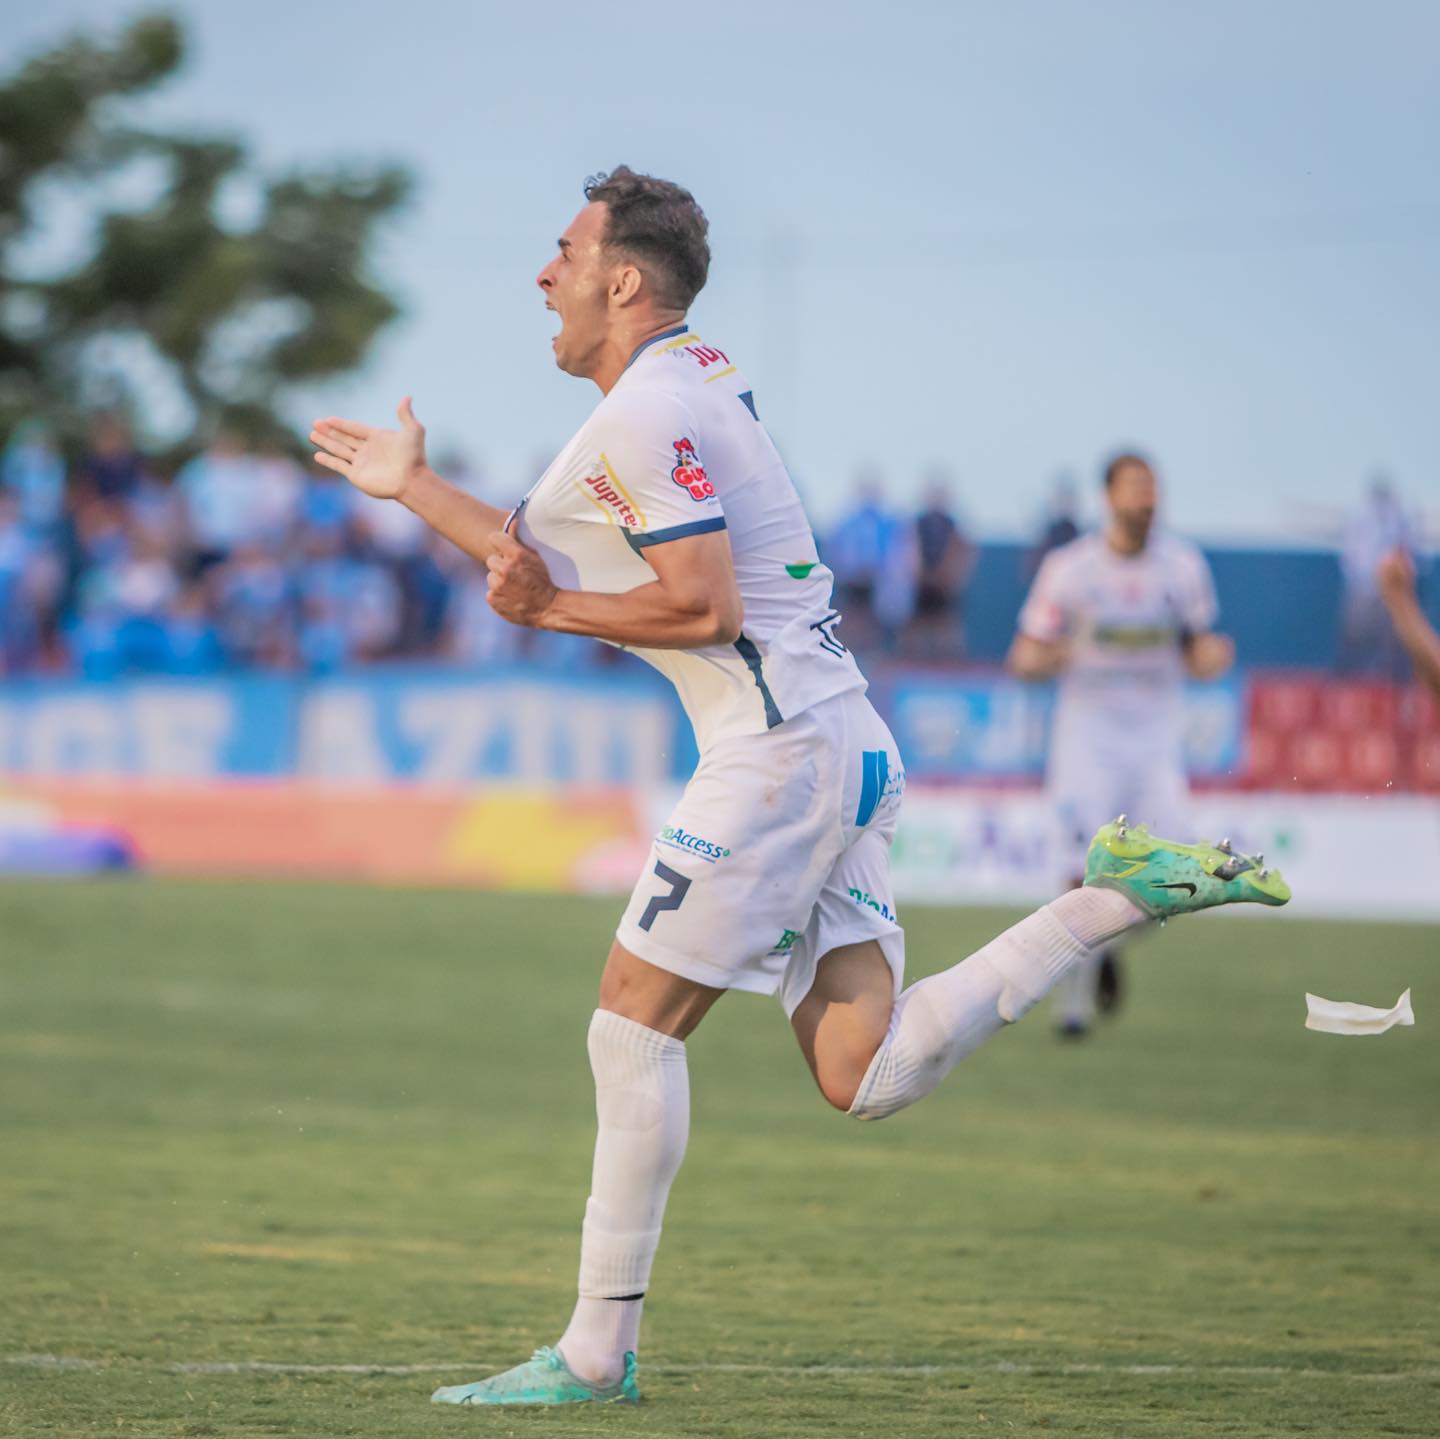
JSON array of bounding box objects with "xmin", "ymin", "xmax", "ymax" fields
[{"xmin": 850, "ymin": 887, "xmax": 1146, "ymax": 1119}]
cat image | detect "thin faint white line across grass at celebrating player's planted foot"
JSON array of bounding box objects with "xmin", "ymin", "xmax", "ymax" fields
[{"xmin": 0, "ymin": 1354, "xmax": 1440, "ymax": 1384}]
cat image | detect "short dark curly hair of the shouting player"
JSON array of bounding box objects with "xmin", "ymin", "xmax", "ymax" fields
[{"xmin": 585, "ymin": 164, "xmax": 710, "ymax": 310}]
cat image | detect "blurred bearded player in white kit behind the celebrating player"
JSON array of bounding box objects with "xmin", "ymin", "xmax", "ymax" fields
[{"xmin": 1008, "ymin": 454, "xmax": 1234, "ymax": 1037}]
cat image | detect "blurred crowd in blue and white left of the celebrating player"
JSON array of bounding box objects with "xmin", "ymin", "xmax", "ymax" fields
[{"xmin": 0, "ymin": 415, "xmax": 567, "ymax": 677}]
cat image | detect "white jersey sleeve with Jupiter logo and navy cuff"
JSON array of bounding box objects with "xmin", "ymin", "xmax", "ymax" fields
[{"xmin": 593, "ymin": 390, "xmax": 726, "ymax": 550}]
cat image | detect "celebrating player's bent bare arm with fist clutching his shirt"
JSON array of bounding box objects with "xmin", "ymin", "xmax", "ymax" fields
[{"xmin": 485, "ymin": 530, "xmax": 743, "ymax": 650}]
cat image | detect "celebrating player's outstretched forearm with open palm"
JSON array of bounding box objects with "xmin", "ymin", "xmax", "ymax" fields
[{"xmin": 310, "ymin": 396, "xmax": 505, "ymax": 563}]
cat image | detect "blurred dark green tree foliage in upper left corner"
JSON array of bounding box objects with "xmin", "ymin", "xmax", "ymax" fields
[{"xmin": 0, "ymin": 14, "xmax": 410, "ymax": 447}]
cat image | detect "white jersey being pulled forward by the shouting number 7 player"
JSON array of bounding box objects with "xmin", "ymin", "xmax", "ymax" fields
[{"xmin": 511, "ymin": 327, "xmax": 865, "ymax": 749}]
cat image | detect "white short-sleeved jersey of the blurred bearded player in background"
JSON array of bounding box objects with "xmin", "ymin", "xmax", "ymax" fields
[{"xmin": 1020, "ymin": 534, "xmax": 1217, "ymax": 756}]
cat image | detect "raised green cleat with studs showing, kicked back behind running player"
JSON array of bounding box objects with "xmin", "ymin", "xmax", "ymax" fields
[{"xmin": 1084, "ymin": 814, "xmax": 1290, "ymax": 919}]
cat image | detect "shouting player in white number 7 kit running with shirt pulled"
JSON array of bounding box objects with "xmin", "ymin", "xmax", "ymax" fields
[{"xmin": 311, "ymin": 167, "xmax": 1289, "ymax": 1404}]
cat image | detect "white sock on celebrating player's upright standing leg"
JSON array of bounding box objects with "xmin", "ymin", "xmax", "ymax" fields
[{"xmin": 559, "ymin": 1010, "xmax": 690, "ymax": 1384}]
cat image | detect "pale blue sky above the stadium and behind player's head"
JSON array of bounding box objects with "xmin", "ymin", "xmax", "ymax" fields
[{"xmin": 0, "ymin": 0, "xmax": 1440, "ymax": 537}]
